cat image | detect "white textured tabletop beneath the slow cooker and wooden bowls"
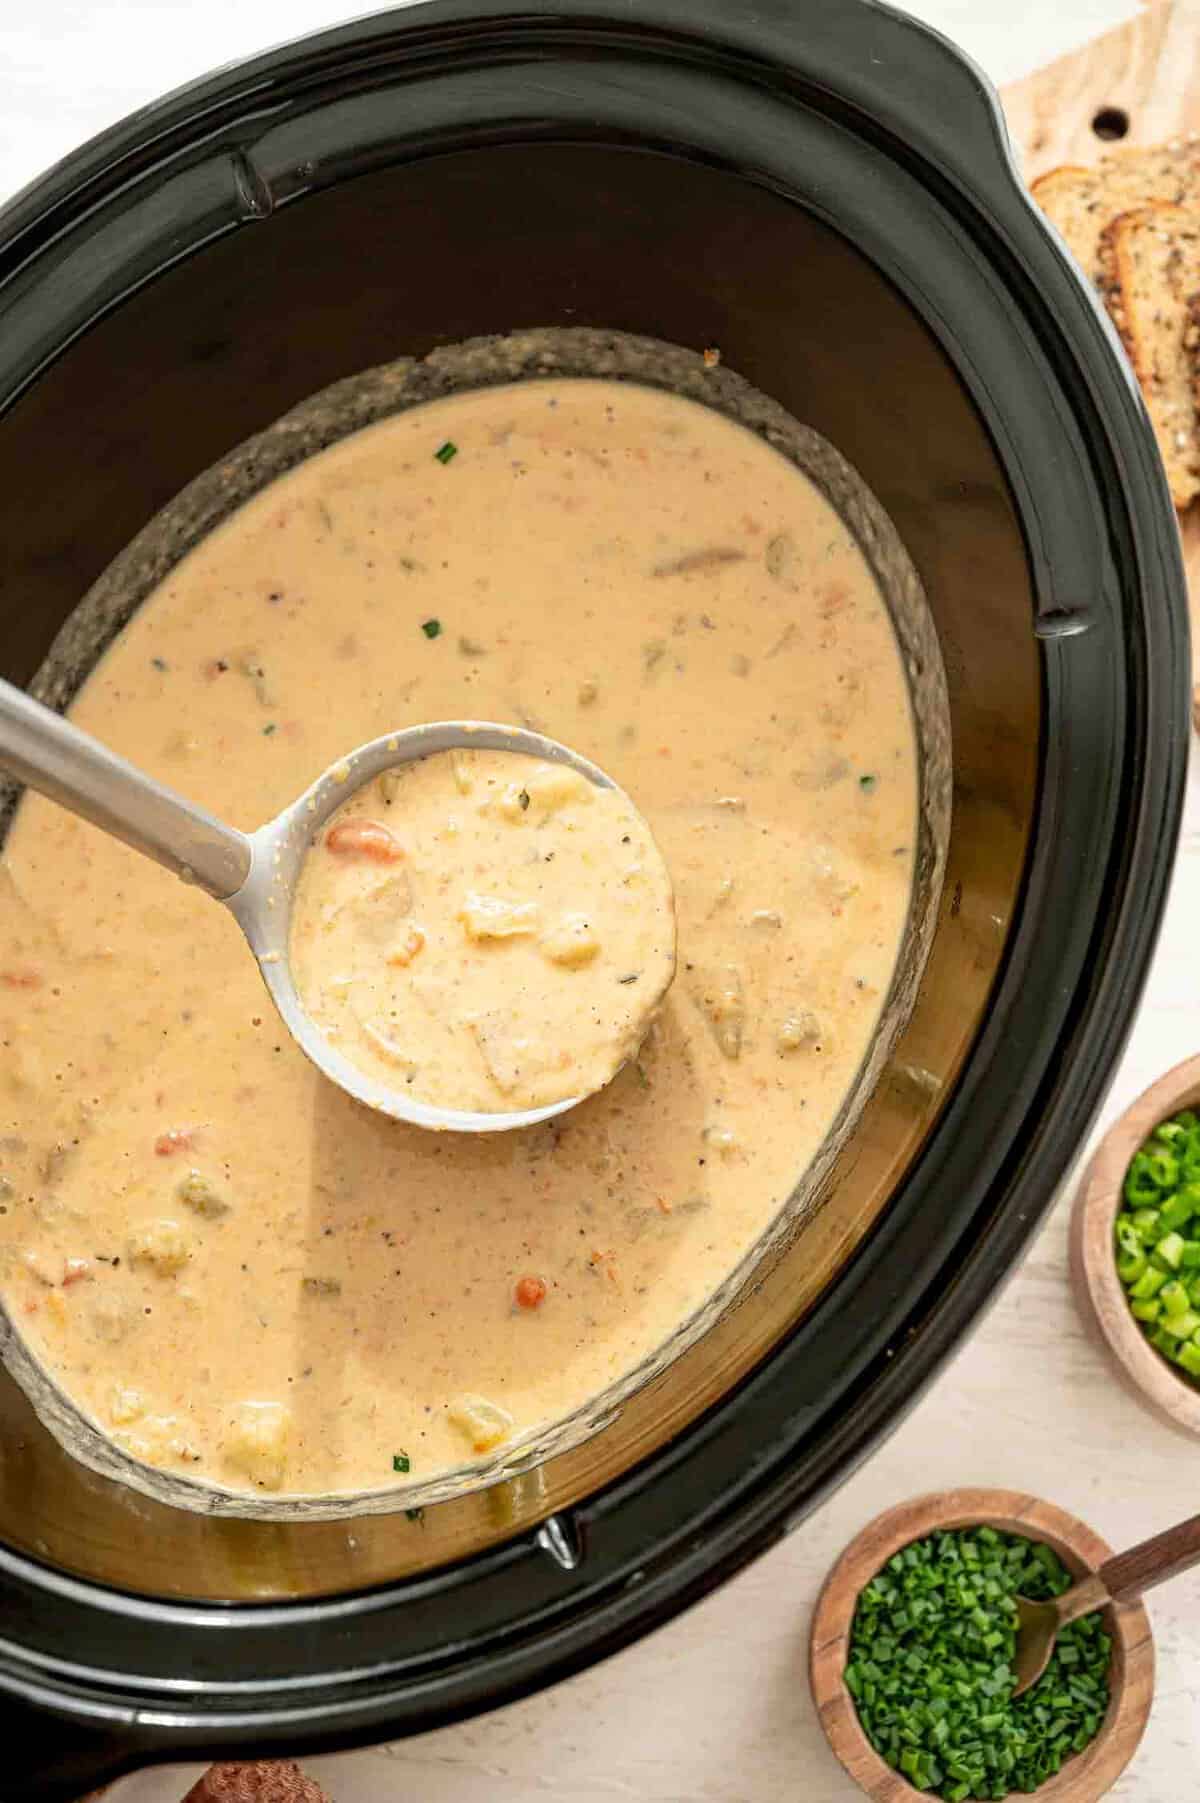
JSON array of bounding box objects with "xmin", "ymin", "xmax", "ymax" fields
[{"xmin": 11, "ymin": 0, "xmax": 1200, "ymax": 1803}]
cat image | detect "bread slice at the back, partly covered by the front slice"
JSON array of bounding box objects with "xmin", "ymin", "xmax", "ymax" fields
[{"xmin": 1031, "ymin": 135, "xmax": 1200, "ymax": 281}]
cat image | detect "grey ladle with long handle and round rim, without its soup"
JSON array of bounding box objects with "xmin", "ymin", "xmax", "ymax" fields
[{"xmin": 0, "ymin": 682, "xmax": 641, "ymax": 1132}]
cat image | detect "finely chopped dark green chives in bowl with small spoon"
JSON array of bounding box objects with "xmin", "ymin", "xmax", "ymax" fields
[{"xmin": 843, "ymin": 1527, "xmax": 1112, "ymax": 1803}]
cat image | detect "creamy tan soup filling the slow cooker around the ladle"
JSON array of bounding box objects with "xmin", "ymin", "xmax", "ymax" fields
[{"xmin": 0, "ymin": 379, "xmax": 917, "ymax": 1498}]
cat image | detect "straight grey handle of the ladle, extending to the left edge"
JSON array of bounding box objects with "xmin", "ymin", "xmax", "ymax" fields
[{"xmin": 0, "ymin": 682, "xmax": 250, "ymax": 902}]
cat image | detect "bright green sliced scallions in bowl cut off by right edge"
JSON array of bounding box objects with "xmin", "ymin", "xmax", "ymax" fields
[{"xmin": 1114, "ymin": 1109, "xmax": 1200, "ymax": 1379}]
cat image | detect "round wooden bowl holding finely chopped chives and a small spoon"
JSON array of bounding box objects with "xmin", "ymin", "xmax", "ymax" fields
[{"xmin": 809, "ymin": 1489, "xmax": 1155, "ymax": 1803}]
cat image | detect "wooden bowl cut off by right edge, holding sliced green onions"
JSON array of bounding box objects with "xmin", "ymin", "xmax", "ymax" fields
[{"xmin": 1070, "ymin": 1058, "xmax": 1200, "ymax": 1433}]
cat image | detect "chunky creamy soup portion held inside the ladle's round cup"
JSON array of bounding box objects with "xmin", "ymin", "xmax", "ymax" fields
[{"xmin": 292, "ymin": 750, "xmax": 676, "ymax": 1114}]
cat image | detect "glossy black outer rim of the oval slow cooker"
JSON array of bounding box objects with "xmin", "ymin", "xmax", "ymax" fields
[{"xmin": 0, "ymin": 0, "xmax": 1189, "ymax": 1799}]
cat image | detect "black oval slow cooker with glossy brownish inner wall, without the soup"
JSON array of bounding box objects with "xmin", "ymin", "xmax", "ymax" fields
[{"xmin": 0, "ymin": 0, "xmax": 1187, "ymax": 1803}]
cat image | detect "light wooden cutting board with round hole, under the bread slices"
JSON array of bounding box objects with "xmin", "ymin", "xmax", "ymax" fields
[{"xmin": 1002, "ymin": 0, "xmax": 1200, "ymax": 710}]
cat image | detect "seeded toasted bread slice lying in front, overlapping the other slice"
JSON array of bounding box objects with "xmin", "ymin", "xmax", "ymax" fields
[{"xmin": 1099, "ymin": 202, "xmax": 1200, "ymax": 508}]
